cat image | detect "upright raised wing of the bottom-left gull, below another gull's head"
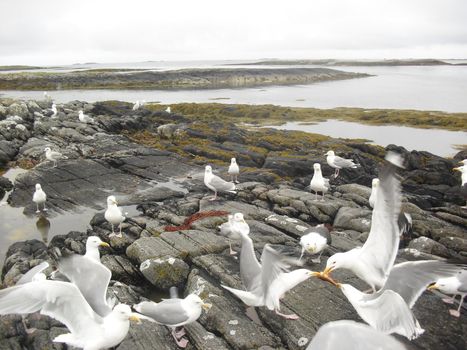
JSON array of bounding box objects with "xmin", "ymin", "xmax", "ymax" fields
[{"xmin": 58, "ymin": 254, "xmax": 112, "ymax": 317}]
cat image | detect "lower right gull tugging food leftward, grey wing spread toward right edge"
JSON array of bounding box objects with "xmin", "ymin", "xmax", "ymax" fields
[{"xmin": 318, "ymin": 260, "xmax": 466, "ymax": 340}]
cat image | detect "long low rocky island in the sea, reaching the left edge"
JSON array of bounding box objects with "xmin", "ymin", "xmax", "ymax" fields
[{"xmin": 0, "ymin": 68, "xmax": 370, "ymax": 90}]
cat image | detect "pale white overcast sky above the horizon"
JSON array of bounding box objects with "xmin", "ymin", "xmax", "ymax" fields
[{"xmin": 0, "ymin": 0, "xmax": 467, "ymax": 65}]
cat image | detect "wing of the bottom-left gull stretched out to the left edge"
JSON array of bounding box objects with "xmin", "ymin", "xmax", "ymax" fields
[{"xmin": 0, "ymin": 280, "xmax": 103, "ymax": 338}]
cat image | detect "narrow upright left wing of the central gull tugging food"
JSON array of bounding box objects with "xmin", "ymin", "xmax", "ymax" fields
[{"xmin": 240, "ymin": 235, "xmax": 262, "ymax": 294}]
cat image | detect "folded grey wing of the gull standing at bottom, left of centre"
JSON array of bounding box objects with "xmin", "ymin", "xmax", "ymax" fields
[{"xmin": 136, "ymin": 299, "xmax": 188, "ymax": 326}]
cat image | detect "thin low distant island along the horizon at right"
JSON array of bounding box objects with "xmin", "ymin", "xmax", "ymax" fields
[{"xmin": 241, "ymin": 58, "xmax": 465, "ymax": 66}]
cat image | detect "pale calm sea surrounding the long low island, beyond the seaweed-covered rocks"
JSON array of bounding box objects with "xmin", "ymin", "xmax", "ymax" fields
[{"xmin": 0, "ymin": 61, "xmax": 467, "ymax": 112}]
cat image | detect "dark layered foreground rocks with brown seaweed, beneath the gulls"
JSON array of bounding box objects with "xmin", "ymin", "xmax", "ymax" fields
[{"xmin": 0, "ymin": 100, "xmax": 467, "ymax": 350}]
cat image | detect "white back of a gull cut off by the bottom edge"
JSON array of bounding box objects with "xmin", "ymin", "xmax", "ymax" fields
[{"xmin": 306, "ymin": 320, "xmax": 407, "ymax": 350}]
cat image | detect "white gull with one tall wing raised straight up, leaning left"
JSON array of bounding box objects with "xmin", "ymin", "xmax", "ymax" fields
[{"xmin": 323, "ymin": 152, "xmax": 401, "ymax": 292}]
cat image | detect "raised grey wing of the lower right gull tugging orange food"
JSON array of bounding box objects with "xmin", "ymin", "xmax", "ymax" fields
[{"xmin": 383, "ymin": 260, "xmax": 461, "ymax": 308}]
